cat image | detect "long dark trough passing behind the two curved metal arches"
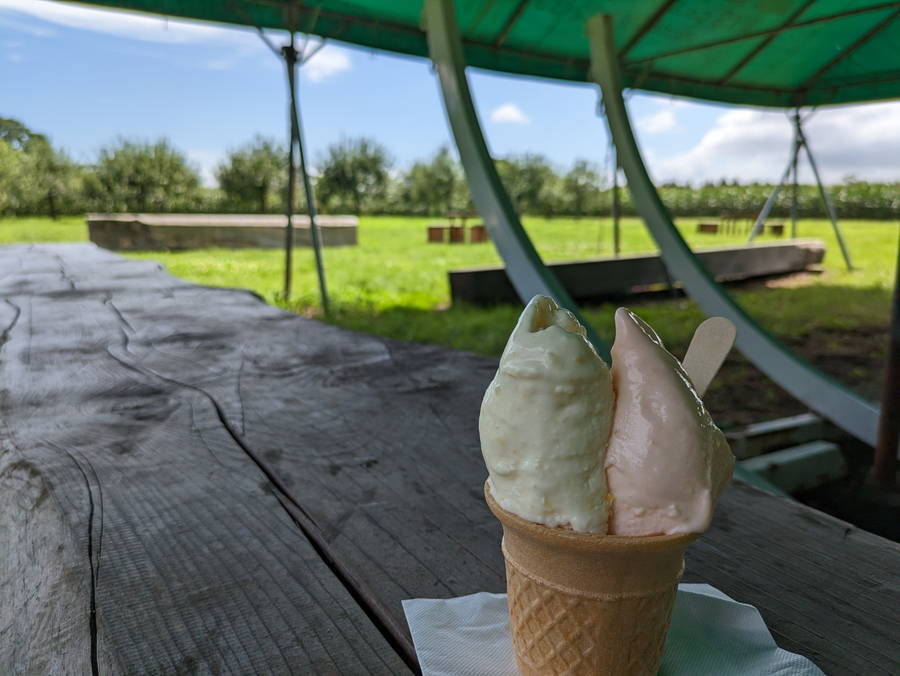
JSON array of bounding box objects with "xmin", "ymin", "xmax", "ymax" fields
[{"xmin": 448, "ymin": 239, "xmax": 825, "ymax": 305}]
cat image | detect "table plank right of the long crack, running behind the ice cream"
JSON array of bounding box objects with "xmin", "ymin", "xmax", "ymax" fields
[{"xmin": 54, "ymin": 247, "xmax": 900, "ymax": 674}]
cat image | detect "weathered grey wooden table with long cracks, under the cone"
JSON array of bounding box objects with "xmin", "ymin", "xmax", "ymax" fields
[{"xmin": 0, "ymin": 244, "xmax": 900, "ymax": 674}]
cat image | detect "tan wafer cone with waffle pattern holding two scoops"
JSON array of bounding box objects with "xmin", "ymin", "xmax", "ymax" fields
[{"xmin": 484, "ymin": 483, "xmax": 697, "ymax": 676}]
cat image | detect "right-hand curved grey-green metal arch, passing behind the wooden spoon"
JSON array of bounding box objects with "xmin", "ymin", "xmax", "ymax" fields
[{"xmin": 587, "ymin": 15, "xmax": 878, "ymax": 445}]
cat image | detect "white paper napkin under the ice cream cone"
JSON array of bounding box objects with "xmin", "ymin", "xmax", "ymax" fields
[{"xmin": 403, "ymin": 584, "xmax": 823, "ymax": 676}]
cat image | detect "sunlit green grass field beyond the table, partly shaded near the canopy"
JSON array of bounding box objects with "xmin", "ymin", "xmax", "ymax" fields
[{"xmin": 131, "ymin": 217, "xmax": 897, "ymax": 355}]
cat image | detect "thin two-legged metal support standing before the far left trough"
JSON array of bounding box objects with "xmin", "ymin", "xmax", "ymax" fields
[{"xmin": 281, "ymin": 32, "xmax": 329, "ymax": 314}]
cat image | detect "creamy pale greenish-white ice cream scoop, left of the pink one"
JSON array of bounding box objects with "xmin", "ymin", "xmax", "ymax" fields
[{"xmin": 479, "ymin": 296, "xmax": 613, "ymax": 533}]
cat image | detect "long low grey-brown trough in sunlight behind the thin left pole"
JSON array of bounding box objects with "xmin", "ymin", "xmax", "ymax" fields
[{"xmin": 87, "ymin": 214, "xmax": 359, "ymax": 251}]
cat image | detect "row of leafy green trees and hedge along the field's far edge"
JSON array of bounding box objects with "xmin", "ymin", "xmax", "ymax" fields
[{"xmin": 0, "ymin": 118, "xmax": 900, "ymax": 219}]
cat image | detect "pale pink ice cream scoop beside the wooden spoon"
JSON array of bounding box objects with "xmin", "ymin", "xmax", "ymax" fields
[{"xmin": 606, "ymin": 308, "xmax": 734, "ymax": 536}]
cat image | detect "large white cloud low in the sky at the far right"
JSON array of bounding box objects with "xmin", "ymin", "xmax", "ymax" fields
[{"xmin": 652, "ymin": 102, "xmax": 900, "ymax": 183}]
